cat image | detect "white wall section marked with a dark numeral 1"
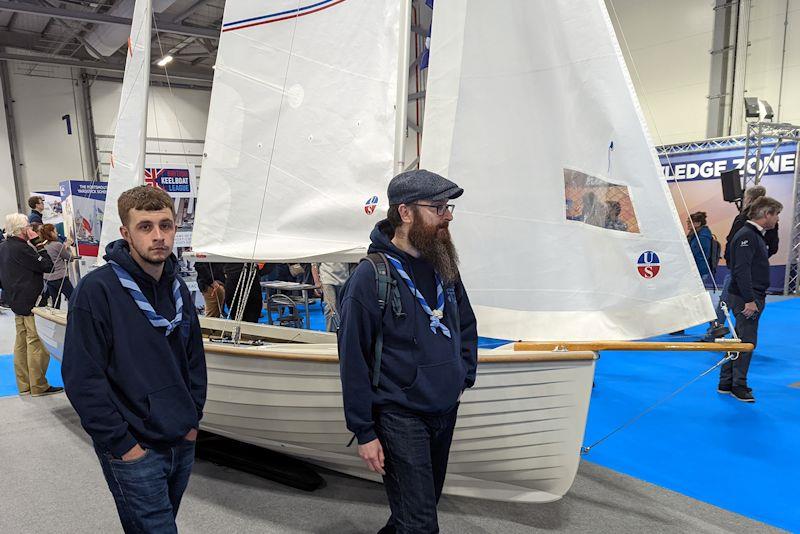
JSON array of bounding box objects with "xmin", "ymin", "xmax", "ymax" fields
[{"xmin": 9, "ymin": 63, "xmax": 83, "ymax": 194}]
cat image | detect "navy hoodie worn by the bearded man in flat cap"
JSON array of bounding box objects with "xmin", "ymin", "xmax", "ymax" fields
[{"xmin": 338, "ymin": 220, "xmax": 478, "ymax": 444}]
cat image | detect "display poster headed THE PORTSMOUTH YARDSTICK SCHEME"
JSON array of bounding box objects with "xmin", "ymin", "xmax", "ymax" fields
[{"xmin": 60, "ymin": 180, "xmax": 107, "ymax": 257}]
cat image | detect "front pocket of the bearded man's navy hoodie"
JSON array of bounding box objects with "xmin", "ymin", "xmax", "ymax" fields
[{"xmin": 405, "ymin": 359, "xmax": 467, "ymax": 411}]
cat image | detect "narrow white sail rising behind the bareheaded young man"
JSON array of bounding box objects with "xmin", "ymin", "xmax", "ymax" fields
[{"xmin": 97, "ymin": 0, "xmax": 153, "ymax": 265}]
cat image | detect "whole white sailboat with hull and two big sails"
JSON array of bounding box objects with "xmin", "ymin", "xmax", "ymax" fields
[{"xmin": 35, "ymin": 0, "xmax": 752, "ymax": 502}]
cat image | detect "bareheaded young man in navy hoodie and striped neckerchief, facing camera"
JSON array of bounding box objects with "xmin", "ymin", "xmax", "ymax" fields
[{"xmin": 62, "ymin": 186, "xmax": 206, "ymax": 532}]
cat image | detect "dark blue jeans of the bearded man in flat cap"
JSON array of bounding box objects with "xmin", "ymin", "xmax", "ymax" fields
[{"xmin": 375, "ymin": 406, "xmax": 458, "ymax": 534}]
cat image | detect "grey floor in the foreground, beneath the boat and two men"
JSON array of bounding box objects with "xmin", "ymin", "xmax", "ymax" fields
[{"xmin": 0, "ymin": 395, "xmax": 780, "ymax": 534}]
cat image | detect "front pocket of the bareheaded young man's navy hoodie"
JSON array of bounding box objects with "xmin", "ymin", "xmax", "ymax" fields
[{"xmin": 144, "ymin": 384, "xmax": 197, "ymax": 442}]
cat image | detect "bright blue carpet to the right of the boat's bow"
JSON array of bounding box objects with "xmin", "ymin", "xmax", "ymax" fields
[{"xmin": 585, "ymin": 299, "xmax": 800, "ymax": 532}]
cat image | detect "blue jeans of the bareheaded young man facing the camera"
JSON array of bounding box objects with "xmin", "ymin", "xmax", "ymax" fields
[{"xmin": 95, "ymin": 440, "xmax": 195, "ymax": 534}]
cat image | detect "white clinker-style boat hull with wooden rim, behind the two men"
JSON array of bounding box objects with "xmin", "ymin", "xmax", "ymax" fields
[{"xmin": 36, "ymin": 312, "xmax": 594, "ymax": 502}]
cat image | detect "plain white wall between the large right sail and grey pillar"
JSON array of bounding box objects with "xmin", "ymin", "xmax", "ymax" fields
[{"xmin": 606, "ymin": 0, "xmax": 714, "ymax": 145}]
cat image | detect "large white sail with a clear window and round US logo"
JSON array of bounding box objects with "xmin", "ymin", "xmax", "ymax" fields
[{"xmin": 421, "ymin": 0, "xmax": 713, "ymax": 340}]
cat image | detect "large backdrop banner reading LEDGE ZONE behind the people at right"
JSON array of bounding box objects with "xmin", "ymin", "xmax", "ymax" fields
[{"xmin": 659, "ymin": 142, "xmax": 797, "ymax": 292}]
